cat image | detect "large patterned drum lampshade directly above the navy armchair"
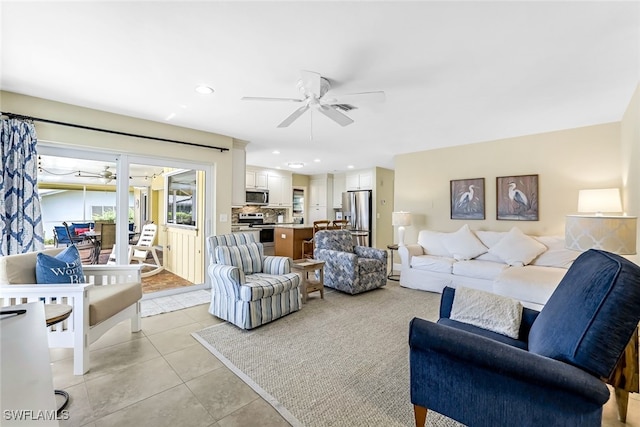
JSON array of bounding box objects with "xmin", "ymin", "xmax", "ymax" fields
[{"xmin": 565, "ymin": 215, "xmax": 637, "ymax": 255}]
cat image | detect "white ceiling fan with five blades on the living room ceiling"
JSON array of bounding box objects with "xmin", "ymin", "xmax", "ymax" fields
[{"xmin": 242, "ymin": 71, "xmax": 385, "ymax": 128}]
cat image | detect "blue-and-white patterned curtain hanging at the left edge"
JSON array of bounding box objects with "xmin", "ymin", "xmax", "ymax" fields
[{"xmin": 0, "ymin": 119, "xmax": 44, "ymax": 256}]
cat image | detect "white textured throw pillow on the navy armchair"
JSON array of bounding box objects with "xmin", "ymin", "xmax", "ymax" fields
[{"xmin": 449, "ymin": 286, "xmax": 522, "ymax": 339}]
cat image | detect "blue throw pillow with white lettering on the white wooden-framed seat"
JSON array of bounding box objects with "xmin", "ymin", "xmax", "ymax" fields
[{"xmin": 36, "ymin": 245, "xmax": 84, "ymax": 285}]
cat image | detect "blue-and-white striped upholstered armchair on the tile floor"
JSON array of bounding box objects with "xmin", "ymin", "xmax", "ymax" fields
[{"xmin": 207, "ymin": 233, "xmax": 301, "ymax": 329}]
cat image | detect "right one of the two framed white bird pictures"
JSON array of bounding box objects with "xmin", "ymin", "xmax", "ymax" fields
[{"xmin": 496, "ymin": 175, "xmax": 539, "ymax": 221}]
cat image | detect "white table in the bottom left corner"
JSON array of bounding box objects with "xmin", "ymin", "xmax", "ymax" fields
[{"xmin": 0, "ymin": 302, "xmax": 59, "ymax": 426}]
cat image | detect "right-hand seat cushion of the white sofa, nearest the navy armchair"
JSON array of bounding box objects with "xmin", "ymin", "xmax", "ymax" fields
[{"xmin": 493, "ymin": 265, "xmax": 567, "ymax": 305}]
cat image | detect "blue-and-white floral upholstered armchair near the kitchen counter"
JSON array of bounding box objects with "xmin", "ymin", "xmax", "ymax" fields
[{"xmin": 313, "ymin": 230, "xmax": 387, "ymax": 295}]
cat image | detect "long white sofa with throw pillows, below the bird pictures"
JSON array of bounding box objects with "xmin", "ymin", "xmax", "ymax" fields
[{"xmin": 398, "ymin": 224, "xmax": 580, "ymax": 310}]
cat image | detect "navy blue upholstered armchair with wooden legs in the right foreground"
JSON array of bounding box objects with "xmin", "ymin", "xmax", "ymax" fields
[{"xmin": 409, "ymin": 250, "xmax": 640, "ymax": 427}]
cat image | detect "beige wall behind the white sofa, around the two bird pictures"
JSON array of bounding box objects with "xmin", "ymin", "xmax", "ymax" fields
[{"xmin": 394, "ymin": 120, "xmax": 624, "ymax": 242}]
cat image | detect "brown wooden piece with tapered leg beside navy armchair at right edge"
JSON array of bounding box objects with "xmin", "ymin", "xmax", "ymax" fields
[{"xmin": 606, "ymin": 328, "xmax": 640, "ymax": 423}]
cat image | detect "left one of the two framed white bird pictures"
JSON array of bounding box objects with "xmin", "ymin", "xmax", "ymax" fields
[{"xmin": 450, "ymin": 178, "xmax": 485, "ymax": 220}]
